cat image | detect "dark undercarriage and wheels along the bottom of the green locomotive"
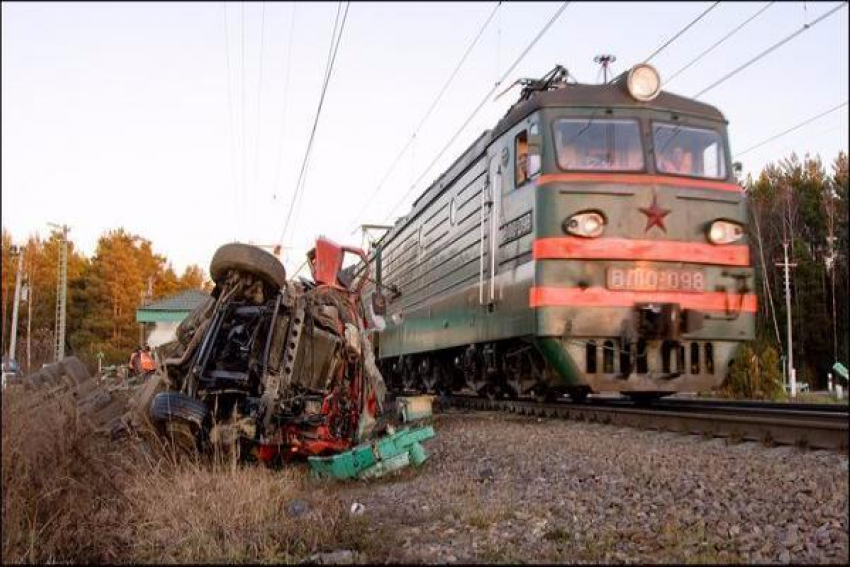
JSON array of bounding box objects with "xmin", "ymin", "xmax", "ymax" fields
[{"xmin": 380, "ymin": 337, "xmax": 737, "ymax": 401}]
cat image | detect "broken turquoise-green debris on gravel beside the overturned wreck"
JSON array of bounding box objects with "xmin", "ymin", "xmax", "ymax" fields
[{"xmin": 307, "ymin": 426, "xmax": 435, "ymax": 479}]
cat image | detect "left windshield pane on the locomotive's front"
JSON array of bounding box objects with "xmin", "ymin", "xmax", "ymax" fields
[{"xmin": 553, "ymin": 117, "xmax": 644, "ymax": 171}]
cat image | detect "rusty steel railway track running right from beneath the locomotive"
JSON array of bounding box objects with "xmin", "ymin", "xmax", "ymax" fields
[{"xmin": 444, "ymin": 395, "xmax": 850, "ymax": 451}]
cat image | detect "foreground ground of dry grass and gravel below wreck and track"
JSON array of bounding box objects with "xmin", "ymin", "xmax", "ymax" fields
[{"xmin": 2, "ymin": 382, "xmax": 848, "ymax": 564}]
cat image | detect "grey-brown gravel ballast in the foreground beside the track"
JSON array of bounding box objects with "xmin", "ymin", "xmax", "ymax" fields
[{"xmin": 328, "ymin": 411, "xmax": 848, "ymax": 564}]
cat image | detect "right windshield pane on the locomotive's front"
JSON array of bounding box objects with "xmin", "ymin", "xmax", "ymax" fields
[{"xmin": 652, "ymin": 124, "xmax": 726, "ymax": 179}]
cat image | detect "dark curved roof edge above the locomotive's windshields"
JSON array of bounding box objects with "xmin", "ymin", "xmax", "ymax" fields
[{"xmin": 493, "ymin": 79, "xmax": 726, "ymax": 137}]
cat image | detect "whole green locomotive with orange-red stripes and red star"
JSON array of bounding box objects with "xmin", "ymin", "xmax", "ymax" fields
[{"xmin": 370, "ymin": 64, "xmax": 757, "ymax": 399}]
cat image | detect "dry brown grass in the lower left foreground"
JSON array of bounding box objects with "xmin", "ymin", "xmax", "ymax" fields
[{"xmin": 2, "ymin": 391, "xmax": 350, "ymax": 563}]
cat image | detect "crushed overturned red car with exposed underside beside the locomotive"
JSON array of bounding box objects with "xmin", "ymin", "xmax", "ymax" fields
[{"xmin": 148, "ymin": 238, "xmax": 385, "ymax": 461}]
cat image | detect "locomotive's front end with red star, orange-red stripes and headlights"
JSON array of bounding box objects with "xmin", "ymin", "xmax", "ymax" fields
[{"xmin": 529, "ymin": 65, "xmax": 757, "ymax": 395}]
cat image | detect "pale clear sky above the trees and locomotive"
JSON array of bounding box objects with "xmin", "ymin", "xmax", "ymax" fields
[{"xmin": 0, "ymin": 2, "xmax": 850, "ymax": 274}]
